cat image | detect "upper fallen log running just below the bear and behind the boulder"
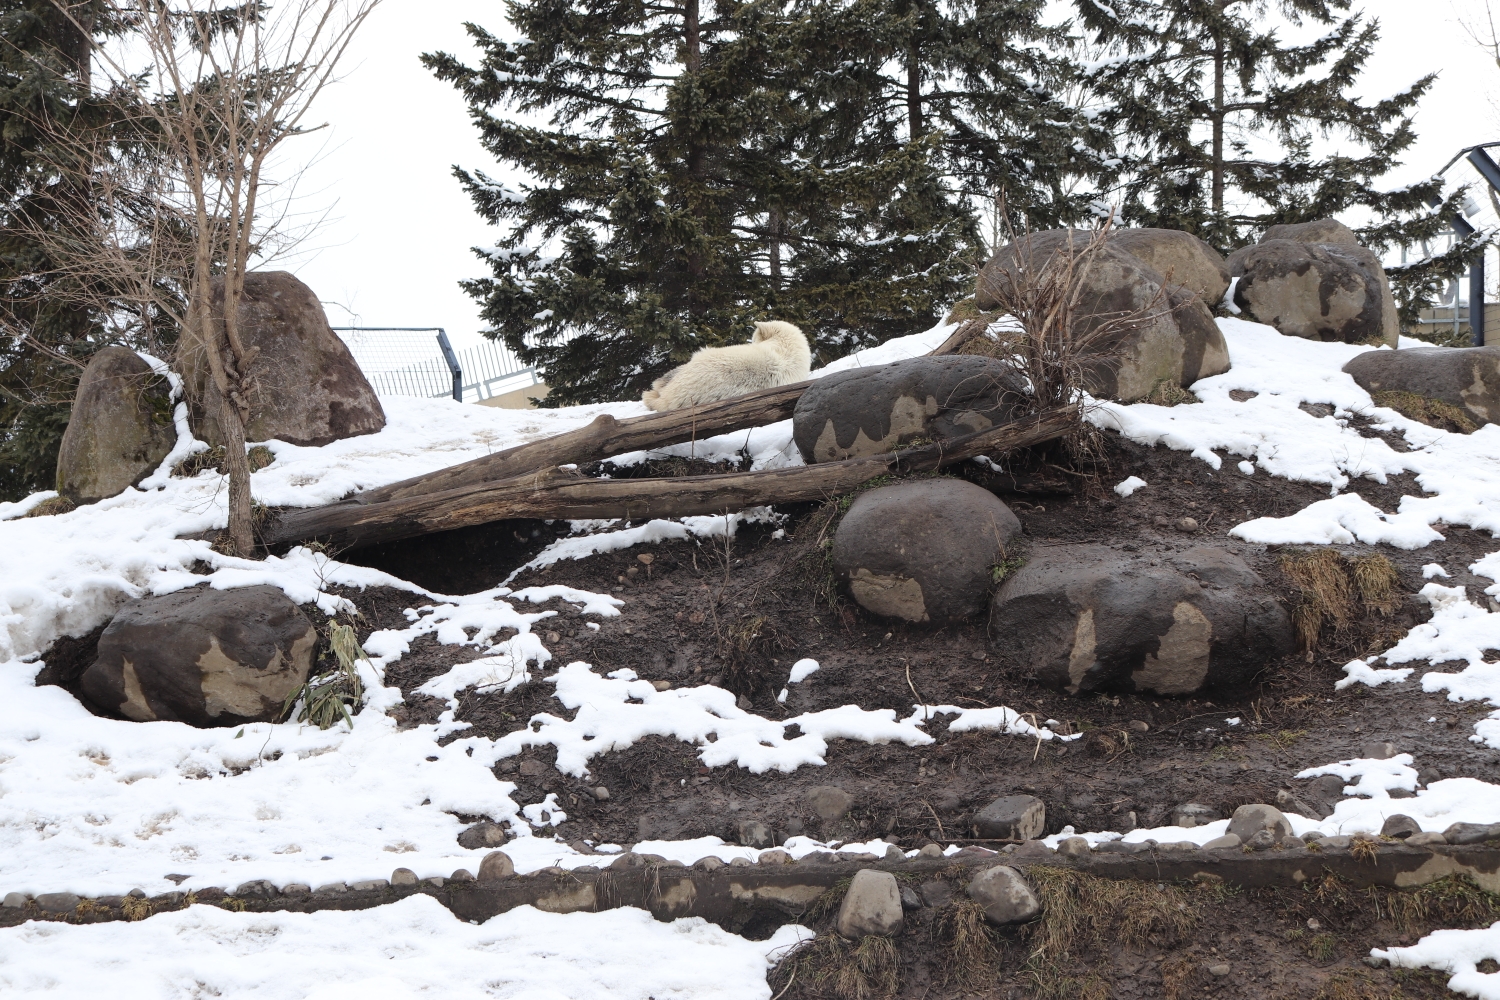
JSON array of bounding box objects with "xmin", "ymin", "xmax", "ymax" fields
[{"xmin": 352, "ymin": 319, "xmax": 984, "ymax": 505}]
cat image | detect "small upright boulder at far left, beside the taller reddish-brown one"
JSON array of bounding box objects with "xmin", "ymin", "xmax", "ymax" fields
[{"xmin": 57, "ymin": 348, "xmax": 177, "ymax": 501}]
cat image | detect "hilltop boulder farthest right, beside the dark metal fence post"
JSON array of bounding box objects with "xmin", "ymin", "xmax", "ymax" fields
[{"xmin": 1229, "ymin": 219, "xmax": 1401, "ymax": 348}]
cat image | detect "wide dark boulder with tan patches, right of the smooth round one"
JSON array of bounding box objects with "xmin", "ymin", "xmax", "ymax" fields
[{"xmin": 990, "ymin": 544, "xmax": 1293, "ymax": 694}]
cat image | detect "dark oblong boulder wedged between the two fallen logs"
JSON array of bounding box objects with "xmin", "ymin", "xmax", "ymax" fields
[{"xmin": 792, "ymin": 355, "xmax": 1025, "ymax": 462}]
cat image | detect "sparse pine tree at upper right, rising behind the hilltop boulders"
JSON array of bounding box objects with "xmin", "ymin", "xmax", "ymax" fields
[{"xmin": 1076, "ymin": 0, "xmax": 1458, "ymax": 293}]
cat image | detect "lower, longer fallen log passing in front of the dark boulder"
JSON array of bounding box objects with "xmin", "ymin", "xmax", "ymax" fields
[{"xmin": 264, "ymin": 406, "xmax": 1079, "ymax": 549}]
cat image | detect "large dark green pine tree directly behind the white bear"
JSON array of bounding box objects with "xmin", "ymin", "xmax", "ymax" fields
[{"xmin": 425, "ymin": 0, "xmax": 977, "ymax": 403}]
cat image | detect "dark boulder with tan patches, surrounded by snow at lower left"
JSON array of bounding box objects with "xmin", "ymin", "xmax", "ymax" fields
[{"xmin": 81, "ymin": 586, "xmax": 318, "ymax": 726}]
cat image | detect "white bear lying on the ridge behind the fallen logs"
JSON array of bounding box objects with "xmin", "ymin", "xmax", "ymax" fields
[{"xmin": 641, "ymin": 322, "xmax": 813, "ymax": 409}]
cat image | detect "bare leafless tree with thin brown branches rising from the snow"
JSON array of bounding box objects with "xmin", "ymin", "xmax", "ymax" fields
[{"xmin": 25, "ymin": 0, "xmax": 380, "ymax": 556}]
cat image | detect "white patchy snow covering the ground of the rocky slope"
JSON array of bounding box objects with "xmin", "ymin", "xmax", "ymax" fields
[{"xmin": 0, "ymin": 319, "xmax": 1500, "ymax": 999}]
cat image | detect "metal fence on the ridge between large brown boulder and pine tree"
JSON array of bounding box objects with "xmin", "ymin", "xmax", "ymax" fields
[{"xmin": 333, "ymin": 327, "xmax": 539, "ymax": 403}]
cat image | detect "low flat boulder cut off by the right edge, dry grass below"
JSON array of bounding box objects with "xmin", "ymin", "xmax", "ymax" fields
[{"xmin": 1344, "ymin": 346, "xmax": 1500, "ymax": 424}]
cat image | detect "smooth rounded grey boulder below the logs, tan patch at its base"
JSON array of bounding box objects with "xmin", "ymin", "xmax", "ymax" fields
[{"xmin": 833, "ymin": 478, "xmax": 1022, "ymax": 622}]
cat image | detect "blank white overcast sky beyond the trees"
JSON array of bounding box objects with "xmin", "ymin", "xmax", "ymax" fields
[{"xmin": 284, "ymin": 0, "xmax": 1500, "ymax": 348}]
